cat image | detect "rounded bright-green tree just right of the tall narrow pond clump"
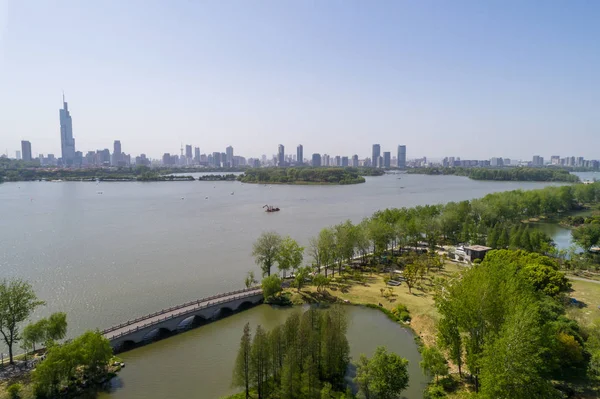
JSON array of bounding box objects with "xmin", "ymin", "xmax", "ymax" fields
[{"xmin": 355, "ymin": 346, "xmax": 408, "ymax": 399}]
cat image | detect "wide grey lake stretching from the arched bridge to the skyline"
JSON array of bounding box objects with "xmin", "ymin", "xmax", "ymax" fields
[{"xmin": 0, "ymin": 175, "xmax": 568, "ymax": 335}]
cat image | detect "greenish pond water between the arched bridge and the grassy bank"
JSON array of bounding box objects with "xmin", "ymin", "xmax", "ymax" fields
[{"xmin": 100, "ymin": 305, "xmax": 427, "ymax": 399}]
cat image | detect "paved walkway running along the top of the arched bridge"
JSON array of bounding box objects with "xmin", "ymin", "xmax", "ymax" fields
[{"xmin": 102, "ymin": 288, "xmax": 262, "ymax": 339}]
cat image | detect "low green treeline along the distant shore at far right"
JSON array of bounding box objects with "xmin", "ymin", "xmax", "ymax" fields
[{"xmin": 408, "ymin": 167, "xmax": 579, "ymax": 183}]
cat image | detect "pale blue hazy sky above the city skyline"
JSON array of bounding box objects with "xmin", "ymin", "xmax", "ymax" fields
[{"xmin": 0, "ymin": 0, "xmax": 600, "ymax": 159}]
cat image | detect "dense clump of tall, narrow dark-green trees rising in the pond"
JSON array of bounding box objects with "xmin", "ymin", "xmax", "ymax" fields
[{"xmin": 233, "ymin": 307, "xmax": 350, "ymax": 399}]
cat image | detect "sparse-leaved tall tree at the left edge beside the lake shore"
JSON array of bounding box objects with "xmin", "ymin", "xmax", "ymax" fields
[{"xmin": 0, "ymin": 279, "xmax": 44, "ymax": 364}]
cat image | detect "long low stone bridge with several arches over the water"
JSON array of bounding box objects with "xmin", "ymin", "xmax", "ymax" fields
[{"xmin": 102, "ymin": 288, "xmax": 263, "ymax": 351}]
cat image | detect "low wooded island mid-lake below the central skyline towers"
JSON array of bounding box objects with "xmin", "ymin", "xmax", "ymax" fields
[{"xmin": 238, "ymin": 167, "xmax": 365, "ymax": 184}]
